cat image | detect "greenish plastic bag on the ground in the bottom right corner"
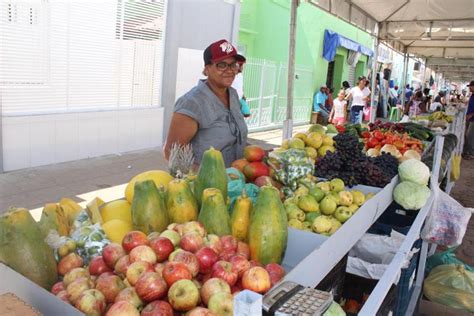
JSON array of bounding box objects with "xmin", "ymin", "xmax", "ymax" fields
[{"xmin": 423, "ymin": 264, "xmax": 474, "ymax": 312}]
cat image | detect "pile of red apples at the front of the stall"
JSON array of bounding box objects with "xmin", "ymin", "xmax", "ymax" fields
[{"xmin": 51, "ymin": 222, "xmax": 285, "ymax": 316}]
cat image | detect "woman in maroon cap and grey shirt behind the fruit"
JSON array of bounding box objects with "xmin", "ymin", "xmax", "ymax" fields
[{"xmin": 164, "ymin": 40, "xmax": 247, "ymax": 167}]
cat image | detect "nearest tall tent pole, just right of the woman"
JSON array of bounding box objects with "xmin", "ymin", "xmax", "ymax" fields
[{"xmin": 283, "ymin": 0, "xmax": 299, "ymax": 140}]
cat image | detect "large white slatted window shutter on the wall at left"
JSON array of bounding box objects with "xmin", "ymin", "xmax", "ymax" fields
[{"xmin": 0, "ymin": 0, "xmax": 166, "ymax": 115}]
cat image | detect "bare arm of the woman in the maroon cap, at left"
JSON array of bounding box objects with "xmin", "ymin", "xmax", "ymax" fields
[{"xmin": 163, "ymin": 113, "xmax": 198, "ymax": 160}]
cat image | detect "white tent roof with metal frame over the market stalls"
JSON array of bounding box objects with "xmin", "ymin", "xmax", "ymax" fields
[{"xmin": 311, "ymin": 0, "xmax": 474, "ymax": 81}]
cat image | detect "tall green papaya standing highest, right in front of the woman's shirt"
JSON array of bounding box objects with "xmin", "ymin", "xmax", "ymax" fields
[{"xmin": 194, "ymin": 147, "xmax": 227, "ymax": 205}]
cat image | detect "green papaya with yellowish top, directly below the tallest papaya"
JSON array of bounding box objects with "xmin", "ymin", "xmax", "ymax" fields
[{"xmin": 198, "ymin": 188, "xmax": 231, "ymax": 236}]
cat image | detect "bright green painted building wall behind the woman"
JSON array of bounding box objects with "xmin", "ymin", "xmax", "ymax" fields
[{"xmin": 239, "ymin": 0, "xmax": 373, "ymax": 94}]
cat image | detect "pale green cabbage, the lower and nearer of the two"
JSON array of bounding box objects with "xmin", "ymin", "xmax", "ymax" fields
[{"xmin": 393, "ymin": 181, "xmax": 431, "ymax": 210}]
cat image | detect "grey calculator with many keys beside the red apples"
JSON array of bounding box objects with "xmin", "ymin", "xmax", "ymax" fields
[{"xmin": 263, "ymin": 281, "xmax": 333, "ymax": 316}]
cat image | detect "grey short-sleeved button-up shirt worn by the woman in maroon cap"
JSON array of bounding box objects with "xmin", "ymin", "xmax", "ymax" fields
[{"xmin": 174, "ymin": 81, "xmax": 247, "ymax": 167}]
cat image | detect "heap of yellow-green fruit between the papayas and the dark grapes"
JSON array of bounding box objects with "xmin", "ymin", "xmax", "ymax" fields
[{"xmin": 284, "ymin": 178, "xmax": 372, "ymax": 236}]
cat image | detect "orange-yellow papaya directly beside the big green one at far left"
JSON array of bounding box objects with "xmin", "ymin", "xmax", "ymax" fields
[{"xmin": 38, "ymin": 203, "xmax": 69, "ymax": 237}]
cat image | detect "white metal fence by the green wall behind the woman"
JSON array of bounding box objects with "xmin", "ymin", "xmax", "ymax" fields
[{"xmin": 243, "ymin": 58, "xmax": 313, "ymax": 131}]
